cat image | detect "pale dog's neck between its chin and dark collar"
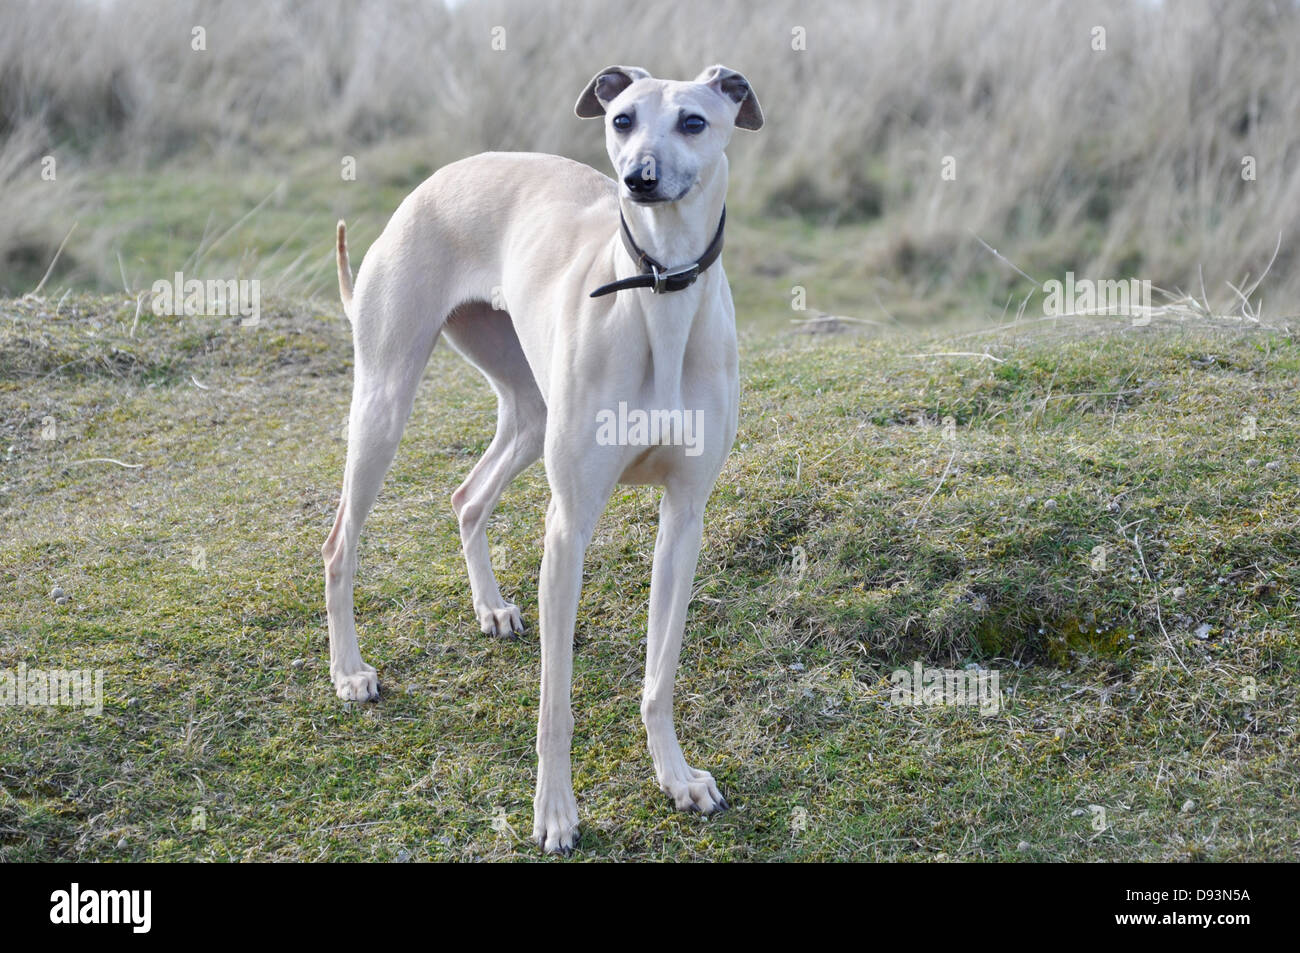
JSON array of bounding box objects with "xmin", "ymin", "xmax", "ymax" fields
[{"xmin": 619, "ymin": 156, "xmax": 727, "ymax": 275}]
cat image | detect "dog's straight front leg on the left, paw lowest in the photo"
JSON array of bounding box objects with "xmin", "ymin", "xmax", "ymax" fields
[{"xmin": 533, "ymin": 495, "xmax": 599, "ymax": 855}]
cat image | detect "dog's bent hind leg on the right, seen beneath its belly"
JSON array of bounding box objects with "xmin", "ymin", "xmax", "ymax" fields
[{"xmin": 445, "ymin": 303, "xmax": 546, "ymax": 636}]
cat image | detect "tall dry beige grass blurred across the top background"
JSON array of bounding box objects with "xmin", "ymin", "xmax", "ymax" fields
[{"xmin": 0, "ymin": 0, "xmax": 1300, "ymax": 313}]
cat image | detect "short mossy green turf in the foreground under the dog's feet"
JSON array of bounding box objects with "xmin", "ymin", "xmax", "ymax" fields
[{"xmin": 0, "ymin": 293, "xmax": 1300, "ymax": 861}]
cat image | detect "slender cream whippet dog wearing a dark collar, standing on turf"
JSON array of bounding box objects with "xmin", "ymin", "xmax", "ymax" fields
[{"xmin": 322, "ymin": 66, "xmax": 763, "ymax": 854}]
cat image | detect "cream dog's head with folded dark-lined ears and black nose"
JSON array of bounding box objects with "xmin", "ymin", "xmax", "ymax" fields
[{"xmin": 573, "ymin": 66, "xmax": 763, "ymax": 205}]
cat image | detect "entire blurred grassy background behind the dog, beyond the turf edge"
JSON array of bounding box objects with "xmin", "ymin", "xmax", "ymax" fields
[{"xmin": 0, "ymin": 0, "xmax": 1300, "ymax": 326}]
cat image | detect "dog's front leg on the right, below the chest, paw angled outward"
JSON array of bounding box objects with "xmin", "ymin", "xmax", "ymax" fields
[{"xmin": 641, "ymin": 486, "xmax": 727, "ymax": 814}]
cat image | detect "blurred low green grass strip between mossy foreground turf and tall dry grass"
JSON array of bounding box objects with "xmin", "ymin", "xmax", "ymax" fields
[{"xmin": 0, "ymin": 154, "xmax": 1024, "ymax": 332}]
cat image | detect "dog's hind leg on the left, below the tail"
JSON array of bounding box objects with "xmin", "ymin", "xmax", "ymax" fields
[{"xmin": 321, "ymin": 282, "xmax": 442, "ymax": 701}]
